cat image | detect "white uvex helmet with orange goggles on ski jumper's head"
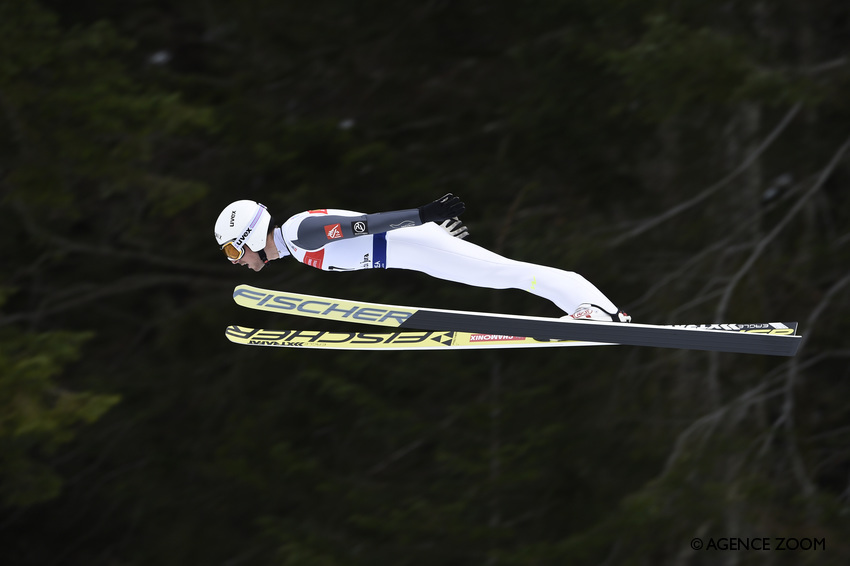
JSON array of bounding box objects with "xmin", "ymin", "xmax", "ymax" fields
[{"xmin": 215, "ymin": 200, "xmax": 272, "ymax": 260}]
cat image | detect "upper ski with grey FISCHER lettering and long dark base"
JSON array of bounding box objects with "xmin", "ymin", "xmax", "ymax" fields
[{"xmin": 233, "ymin": 285, "xmax": 802, "ymax": 356}]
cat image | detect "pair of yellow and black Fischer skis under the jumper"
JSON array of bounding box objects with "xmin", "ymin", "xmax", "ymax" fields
[{"xmin": 225, "ymin": 285, "xmax": 802, "ymax": 356}]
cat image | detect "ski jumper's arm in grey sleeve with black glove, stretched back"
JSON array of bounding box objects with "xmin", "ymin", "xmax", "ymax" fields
[{"xmin": 292, "ymin": 194, "xmax": 463, "ymax": 250}]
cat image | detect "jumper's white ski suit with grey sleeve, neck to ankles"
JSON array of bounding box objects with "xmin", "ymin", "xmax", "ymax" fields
[{"xmin": 274, "ymin": 209, "xmax": 617, "ymax": 313}]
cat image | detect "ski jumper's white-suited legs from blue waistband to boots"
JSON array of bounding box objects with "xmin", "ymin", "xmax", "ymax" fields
[{"xmin": 387, "ymin": 223, "xmax": 617, "ymax": 313}]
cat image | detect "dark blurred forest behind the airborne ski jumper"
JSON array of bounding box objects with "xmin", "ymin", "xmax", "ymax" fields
[{"xmin": 0, "ymin": 0, "xmax": 850, "ymax": 566}]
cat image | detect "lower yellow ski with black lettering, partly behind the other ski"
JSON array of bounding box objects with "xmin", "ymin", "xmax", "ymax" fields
[{"xmin": 225, "ymin": 326, "xmax": 616, "ymax": 351}]
